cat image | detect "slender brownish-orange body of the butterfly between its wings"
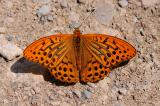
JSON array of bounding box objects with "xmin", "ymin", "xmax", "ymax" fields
[{"xmin": 73, "ymin": 29, "xmax": 81, "ymax": 70}]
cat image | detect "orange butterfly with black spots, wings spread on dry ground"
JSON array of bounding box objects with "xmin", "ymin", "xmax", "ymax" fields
[{"xmin": 23, "ymin": 28, "xmax": 136, "ymax": 83}]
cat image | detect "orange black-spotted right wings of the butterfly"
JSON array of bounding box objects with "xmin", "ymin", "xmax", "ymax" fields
[{"xmin": 80, "ymin": 34, "xmax": 136, "ymax": 82}]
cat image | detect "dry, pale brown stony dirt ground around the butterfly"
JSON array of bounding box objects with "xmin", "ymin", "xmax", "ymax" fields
[{"xmin": 0, "ymin": 0, "xmax": 160, "ymax": 106}]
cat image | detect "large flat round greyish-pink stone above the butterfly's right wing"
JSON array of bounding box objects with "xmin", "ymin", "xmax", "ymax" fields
[{"xmin": 95, "ymin": 4, "xmax": 115, "ymax": 25}]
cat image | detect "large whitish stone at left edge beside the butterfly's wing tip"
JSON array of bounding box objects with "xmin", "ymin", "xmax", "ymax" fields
[{"xmin": 0, "ymin": 38, "xmax": 22, "ymax": 60}]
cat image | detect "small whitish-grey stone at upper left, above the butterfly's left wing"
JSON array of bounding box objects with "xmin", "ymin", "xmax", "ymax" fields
[{"xmin": 36, "ymin": 5, "xmax": 51, "ymax": 17}]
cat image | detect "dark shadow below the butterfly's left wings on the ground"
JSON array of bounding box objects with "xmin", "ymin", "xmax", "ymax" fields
[{"xmin": 11, "ymin": 57, "xmax": 72, "ymax": 86}]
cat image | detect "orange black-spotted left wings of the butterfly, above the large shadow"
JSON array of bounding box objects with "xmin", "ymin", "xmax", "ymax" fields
[{"xmin": 23, "ymin": 34, "xmax": 79, "ymax": 83}]
